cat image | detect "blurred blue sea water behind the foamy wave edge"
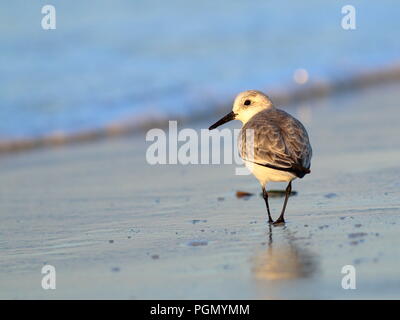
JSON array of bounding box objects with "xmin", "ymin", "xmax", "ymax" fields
[{"xmin": 0, "ymin": 0, "xmax": 400, "ymax": 140}]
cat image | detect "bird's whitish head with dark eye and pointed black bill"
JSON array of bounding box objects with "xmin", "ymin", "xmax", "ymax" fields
[{"xmin": 209, "ymin": 90, "xmax": 273, "ymax": 130}]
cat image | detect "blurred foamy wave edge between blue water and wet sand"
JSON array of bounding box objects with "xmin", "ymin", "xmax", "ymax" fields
[{"xmin": 0, "ymin": 62, "xmax": 400, "ymax": 156}]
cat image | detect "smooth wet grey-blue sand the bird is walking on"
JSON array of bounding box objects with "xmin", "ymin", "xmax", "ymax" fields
[{"xmin": 0, "ymin": 85, "xmax": 400, "ymax": 299}]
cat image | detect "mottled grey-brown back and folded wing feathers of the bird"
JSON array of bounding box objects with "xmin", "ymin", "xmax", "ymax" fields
[{"xmin": 238, "ymin": 108, "xmax": 312, "ymax": 177}]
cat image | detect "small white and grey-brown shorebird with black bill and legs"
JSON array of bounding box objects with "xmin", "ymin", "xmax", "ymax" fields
[{"xmin": 209, "ymin": 90, "xmax": 312, "ymax": 224}]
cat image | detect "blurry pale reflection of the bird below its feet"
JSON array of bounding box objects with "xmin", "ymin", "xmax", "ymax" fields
[{"xmin": 253, "ymin": 226, "xmax": 317, "ymax": 280}]
